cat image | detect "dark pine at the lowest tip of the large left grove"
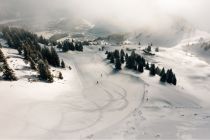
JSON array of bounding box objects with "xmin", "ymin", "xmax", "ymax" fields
[{"xmin": 38, "ymin": 60, "xmax": 53, "ymax": 83}]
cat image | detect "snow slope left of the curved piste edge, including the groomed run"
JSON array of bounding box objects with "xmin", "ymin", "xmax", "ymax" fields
[{"xmin": 0, "ymin": 40, "xmax": 143, "ymax": 139}]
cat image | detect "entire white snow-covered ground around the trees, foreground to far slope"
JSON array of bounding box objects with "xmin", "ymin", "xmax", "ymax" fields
[{"xmin": 0, "ymin": 32, "xmax": 210, "ymax": 140}]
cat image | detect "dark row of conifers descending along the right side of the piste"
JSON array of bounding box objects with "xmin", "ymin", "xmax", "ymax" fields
[{"xmin": 106, "ymin": 50, "xmax": 177, "ymax": 85}]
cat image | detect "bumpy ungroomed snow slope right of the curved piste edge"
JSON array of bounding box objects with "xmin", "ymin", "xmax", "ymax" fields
[{"xmin": 94, "ymin": 45, "xmax": 210, "ymax": 139}]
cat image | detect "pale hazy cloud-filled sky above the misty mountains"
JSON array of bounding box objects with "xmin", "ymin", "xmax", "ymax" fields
[{"xmin": 0, "ymin": 0, "xmax": 210, "ymax": 31}]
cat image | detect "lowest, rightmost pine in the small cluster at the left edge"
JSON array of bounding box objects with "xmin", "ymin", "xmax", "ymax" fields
[{"xmin": 3, "ymin": 62, "xmax": 17, "ymax": 81}]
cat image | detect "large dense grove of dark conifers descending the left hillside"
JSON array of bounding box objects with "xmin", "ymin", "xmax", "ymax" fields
[{"xmin": 2, "ymin": 27, "xmax": 65, "ymax": 82}]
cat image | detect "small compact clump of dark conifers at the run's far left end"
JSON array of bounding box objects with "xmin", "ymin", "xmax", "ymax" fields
[{"xmin": 57, "ymin": 40, "xmax": 83, "ymax": 52}]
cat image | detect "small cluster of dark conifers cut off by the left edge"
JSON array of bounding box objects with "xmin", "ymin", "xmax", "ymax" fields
[{"xmin": 0, "ymin": 49, "xmax": 17, "ymax": 81}]
